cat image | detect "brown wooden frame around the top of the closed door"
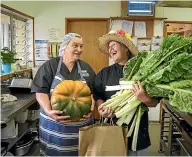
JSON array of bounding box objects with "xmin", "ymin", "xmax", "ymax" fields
[{"xmin": 65, "ymin": 17, "xmax": 110, "ymax": 34}]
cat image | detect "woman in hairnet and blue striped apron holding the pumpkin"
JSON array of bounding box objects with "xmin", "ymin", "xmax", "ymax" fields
[{"xmin": 32, "ymin": 33, "xmax": 95, "ymax": 156}]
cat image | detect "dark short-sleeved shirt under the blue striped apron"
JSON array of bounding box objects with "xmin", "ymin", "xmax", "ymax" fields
[{"xmin": 31, "ymin": 57, "xmax": 95, "ymax": 94}]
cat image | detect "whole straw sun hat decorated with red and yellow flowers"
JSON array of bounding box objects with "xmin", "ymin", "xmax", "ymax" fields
[{"xmin": 99, "ymin": 30, "xmax": 138, "ymax": 56}]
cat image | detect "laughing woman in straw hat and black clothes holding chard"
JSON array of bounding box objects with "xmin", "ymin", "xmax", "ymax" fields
[{"xmin": 94, "ymin": 30, "xmax": 158, "ymax": 156}]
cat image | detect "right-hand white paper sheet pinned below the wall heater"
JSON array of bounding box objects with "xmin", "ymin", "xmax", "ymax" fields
[{"xmin": 135, "ymin": 21, "xmax": 147, "ymax": 38}]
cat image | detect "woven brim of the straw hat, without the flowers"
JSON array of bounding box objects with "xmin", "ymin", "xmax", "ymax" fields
[{"xmin": 98, "ymin": 34, "xmax": 139, "ymax": 56}]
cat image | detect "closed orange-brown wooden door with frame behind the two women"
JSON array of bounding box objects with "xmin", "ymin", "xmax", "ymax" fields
[{"xmin": 65, "ymin": 18, "xmax": 109, "ymax": 73}]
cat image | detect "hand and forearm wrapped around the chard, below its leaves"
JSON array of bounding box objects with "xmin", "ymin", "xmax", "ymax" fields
[{"xmin": 132, "ymin": 82, "xmax": 158, "ymax": 107}]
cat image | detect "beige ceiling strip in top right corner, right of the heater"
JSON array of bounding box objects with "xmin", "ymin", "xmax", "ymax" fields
[{"xmin": 156, "ymin": 0, "xmax": 192, "ymax": 8}]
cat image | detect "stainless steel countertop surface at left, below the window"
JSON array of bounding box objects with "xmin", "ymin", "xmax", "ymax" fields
[{"xmin": 1, "ymin": 93, "xmax": 36, "ymax": 124}]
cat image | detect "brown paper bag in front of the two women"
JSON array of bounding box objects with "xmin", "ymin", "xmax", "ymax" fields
[{"xmin": 79, "ymin": 124, "xmax": 127, "ymax": 156}]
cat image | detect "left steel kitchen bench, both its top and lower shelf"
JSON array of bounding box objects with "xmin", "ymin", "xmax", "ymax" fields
[{"xmin": 1, "ymin": 93, "xmax": 37, "ymax": 151}]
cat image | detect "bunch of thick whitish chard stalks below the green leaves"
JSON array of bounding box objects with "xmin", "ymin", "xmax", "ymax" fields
[{"xmin": 102, "ymin": 81, "xmax": 146, "ymax": 151}]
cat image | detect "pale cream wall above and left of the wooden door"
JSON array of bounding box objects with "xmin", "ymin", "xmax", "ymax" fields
[{"xmin": 35, "ymin": 1, "xmax": 121, "ymax": 39}]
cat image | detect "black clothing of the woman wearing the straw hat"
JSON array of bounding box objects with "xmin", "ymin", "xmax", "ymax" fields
[{"xmin": 93, "ymin": 64, "xmax": 151, "ymax": 150}]
